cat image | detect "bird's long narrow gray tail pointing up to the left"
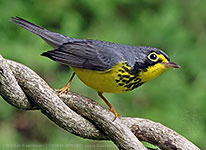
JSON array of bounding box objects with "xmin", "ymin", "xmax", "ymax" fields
[{"xmin": 11, "ymin": 17, "xmax": 74, "ymax": 48}]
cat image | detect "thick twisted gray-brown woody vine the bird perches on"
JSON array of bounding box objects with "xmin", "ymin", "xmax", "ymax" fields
[{"xmin": 0, "ymin": 55, "xmax": 199, "ymax": 150}]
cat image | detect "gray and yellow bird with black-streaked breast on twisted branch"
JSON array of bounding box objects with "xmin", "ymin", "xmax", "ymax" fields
[{"xmin": 11, "ymin": 16, "xmax": 180, "ymax": 120}]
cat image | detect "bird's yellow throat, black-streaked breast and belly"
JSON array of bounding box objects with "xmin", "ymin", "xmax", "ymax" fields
[{"xmin": 72, "ymin": 62, "xmax": 167, "ymax": 93}]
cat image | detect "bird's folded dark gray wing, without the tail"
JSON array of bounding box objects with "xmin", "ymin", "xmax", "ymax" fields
[{"xmin": 42, "ymin": 40, "xmax": 124, "ymax": 71}]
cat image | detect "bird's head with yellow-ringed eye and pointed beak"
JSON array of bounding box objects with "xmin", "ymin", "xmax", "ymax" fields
[{"xmin": 132, "ymin": 47, "xmax": 180, "ymax": 82}]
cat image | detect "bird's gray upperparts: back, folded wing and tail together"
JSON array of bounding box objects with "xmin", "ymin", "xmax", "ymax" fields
[{"xmin": 12, "ymin": 17, "xmax": 141, "ymax": 71}]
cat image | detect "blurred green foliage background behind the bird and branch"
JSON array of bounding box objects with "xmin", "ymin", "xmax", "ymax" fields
[{"xmin": 0, "ymin": 0, "xmax": 206, "ymax": 150}]
